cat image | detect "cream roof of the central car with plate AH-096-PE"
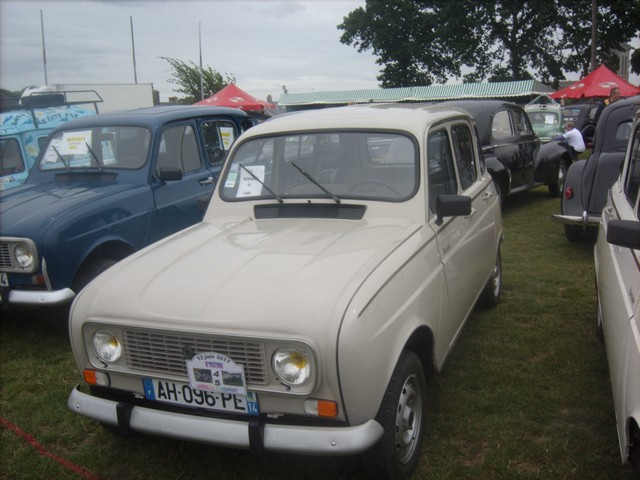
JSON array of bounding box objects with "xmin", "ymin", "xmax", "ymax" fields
[{"xmin": 238, "ymin": 103, "xmax": 472, "ymax": 138}]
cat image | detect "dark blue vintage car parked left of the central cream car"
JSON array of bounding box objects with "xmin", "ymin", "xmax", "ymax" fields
[{"xmin": 0, "ymin": 106, "xmax": 253, "ymax": 305}]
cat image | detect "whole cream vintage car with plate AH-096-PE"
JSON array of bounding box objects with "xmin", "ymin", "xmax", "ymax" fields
[{"xmin": 68, "ymin": 104, "xmax": 502, "ymax": 478}]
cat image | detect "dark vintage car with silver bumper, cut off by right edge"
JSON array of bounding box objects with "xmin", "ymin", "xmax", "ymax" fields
[{"xmin": 552, "ymin": 96, "xmax": 640, "ymax": 242}]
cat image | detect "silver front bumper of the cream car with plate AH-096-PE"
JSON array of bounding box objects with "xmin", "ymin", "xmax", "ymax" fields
[{"xmin": 67, "ymin": 386, "xmax": 383, "ymax": 455}]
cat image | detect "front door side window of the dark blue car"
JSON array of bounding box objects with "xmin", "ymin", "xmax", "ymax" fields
[{"xmin": 156, "ymin": 125, "xmax": 202, "ymax": 174}]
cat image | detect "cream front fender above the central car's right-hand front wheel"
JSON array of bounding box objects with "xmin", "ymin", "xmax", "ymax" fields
[{"xmin": 337, "ymin": 227, "xmax": 447, "ymax": 424}]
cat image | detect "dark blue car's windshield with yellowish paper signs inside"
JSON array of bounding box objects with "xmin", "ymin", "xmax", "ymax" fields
[{"xmin": 39, "ymin": 126, "xmax": 151, "ymax": 171}]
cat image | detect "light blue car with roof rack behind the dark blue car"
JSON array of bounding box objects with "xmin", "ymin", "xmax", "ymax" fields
[{"xmin": 0, "ymin": 91, "xmax": 102, "ymax": 190}]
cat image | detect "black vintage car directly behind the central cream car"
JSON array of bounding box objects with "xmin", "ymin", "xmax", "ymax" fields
[{"xmin": 442, "ymin": 100, "xmax": 571, "ymax": 203}]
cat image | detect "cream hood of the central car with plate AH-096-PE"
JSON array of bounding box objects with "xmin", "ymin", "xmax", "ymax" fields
[{"xmin": 74, "ymin": 217, "xmax": 419, "ymax": 338}]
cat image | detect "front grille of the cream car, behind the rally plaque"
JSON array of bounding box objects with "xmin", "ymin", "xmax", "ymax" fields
[{"xmin": 123, "ymin": 330, "xmax": 267, "ymax": 385}]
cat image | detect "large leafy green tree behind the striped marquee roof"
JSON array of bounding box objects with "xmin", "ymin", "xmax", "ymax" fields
[{"xmin": 338, "ymin": 0, "xmax": 640, "ymax": 87}]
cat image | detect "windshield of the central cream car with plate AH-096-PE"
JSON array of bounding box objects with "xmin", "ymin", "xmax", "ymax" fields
[{"xmin": 220, "ymin": 132, "xmax": 418, "ymax": 202}]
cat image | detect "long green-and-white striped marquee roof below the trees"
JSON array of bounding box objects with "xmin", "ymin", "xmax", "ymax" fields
[{"xmin": 278, "ymin": 80, "xmax": 554, "ymax": 107}]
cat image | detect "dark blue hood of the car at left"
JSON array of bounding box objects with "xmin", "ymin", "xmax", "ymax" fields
[{"xmin": 0, "ymin": 181, "xmax": 141, "ymax": 237}]
